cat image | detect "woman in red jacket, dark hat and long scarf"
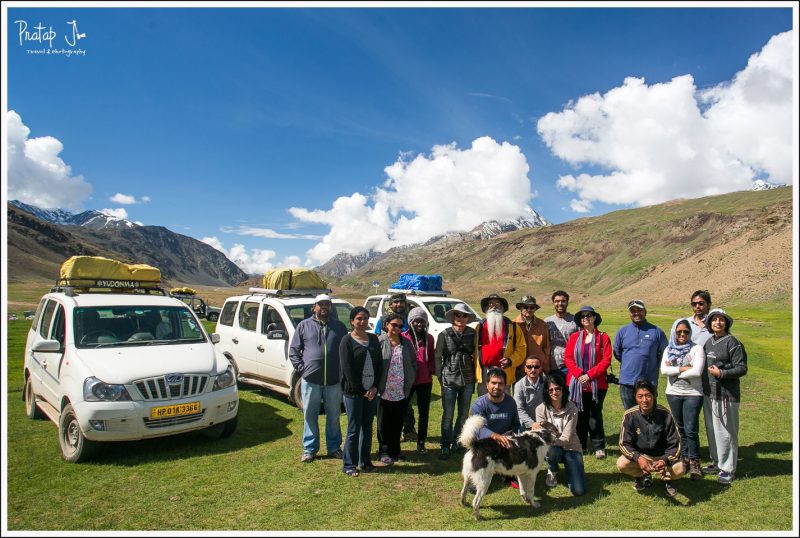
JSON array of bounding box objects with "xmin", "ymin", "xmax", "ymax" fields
[{"xmin": 564, "ymin": 306, "xmax": 611, "ymax": 460}]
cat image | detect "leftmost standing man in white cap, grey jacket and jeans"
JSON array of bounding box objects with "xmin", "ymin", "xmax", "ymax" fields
[{"xmin": 289, "ymin": 294, "xmax": 347, "ymax": 463}]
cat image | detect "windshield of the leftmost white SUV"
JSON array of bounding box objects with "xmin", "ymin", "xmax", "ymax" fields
[{"xmin": 73, "ymin": 306, "xmax": 206, "ymax": 348}]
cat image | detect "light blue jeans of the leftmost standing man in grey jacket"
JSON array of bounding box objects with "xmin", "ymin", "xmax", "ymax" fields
[{"xmin": 300, "ymin": 379, "xmax": 342, "ymax": 454}]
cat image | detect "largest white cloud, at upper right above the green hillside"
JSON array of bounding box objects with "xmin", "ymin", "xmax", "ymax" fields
[{"xmin": 537, "ymin": 28, "xmax": 793, "ymax": 212}]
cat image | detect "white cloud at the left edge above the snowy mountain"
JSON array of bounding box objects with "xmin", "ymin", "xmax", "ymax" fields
[{"xmin": 6, "ymin": 110, "xmax": 92, "ymax": 210}]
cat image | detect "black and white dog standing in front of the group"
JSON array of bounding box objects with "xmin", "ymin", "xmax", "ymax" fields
[{"xmin": 458, "ymin": 415, "xmax": 558, "ymax": 520}]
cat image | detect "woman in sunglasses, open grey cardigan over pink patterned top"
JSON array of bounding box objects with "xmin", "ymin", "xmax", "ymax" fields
[{"xmin": 378, "ymin": 313, "xmax": 417, "ymax": 465}]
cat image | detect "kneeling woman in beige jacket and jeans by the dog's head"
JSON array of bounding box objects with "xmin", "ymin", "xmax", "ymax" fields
[{"xmin": 533, "ymin": 374, "xmax": 586, "ymax": 497}]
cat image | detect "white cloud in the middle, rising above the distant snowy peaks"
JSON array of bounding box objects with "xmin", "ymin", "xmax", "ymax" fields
[{"xmin": 289, "ymin": 137, "xmax": 531, "ymax": 263}]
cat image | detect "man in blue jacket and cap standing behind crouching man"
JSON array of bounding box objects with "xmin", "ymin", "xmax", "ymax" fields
[{"xmin": 614, "ymin": 299, "xmax": 667, "ymax": 410}]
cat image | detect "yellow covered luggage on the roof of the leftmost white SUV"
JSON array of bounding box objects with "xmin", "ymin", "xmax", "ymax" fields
[{"xmin": 60, "ymin": 256, "xmax": 161, "ymax": 287}]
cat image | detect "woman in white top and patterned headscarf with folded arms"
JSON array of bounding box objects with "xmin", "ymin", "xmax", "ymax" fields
[{"xmin": 661, "ymin": 319, "xmax": 706, "ymax": 480}]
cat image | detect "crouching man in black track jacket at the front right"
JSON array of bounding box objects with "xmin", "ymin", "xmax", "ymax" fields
[{"xmin": 617, "ymin": 379, "xmax": 685, "ymax": 497}]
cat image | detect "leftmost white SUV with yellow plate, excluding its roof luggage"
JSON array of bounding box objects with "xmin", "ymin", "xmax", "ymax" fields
[{"xmin": 23, "ymin": 280, "xmax": 239, "ymax": 462}]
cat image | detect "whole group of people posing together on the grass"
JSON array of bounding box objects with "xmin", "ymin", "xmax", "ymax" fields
[{"xmin": 289, "ymin": 290, "xmax": 747, "ymax": 496}]
